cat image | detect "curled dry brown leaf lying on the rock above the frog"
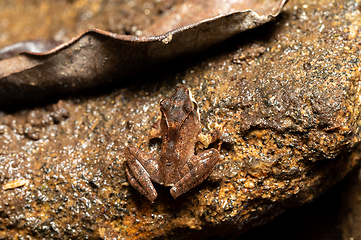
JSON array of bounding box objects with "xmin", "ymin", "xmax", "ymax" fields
[{"xmin": 0, "ymin": 0, "xmax": 287, "ymax": 106}]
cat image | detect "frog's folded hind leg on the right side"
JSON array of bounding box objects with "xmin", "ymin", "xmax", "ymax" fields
[{"xmin": 170, "ymin": 148, "xmax": 220, "ymax": 198}]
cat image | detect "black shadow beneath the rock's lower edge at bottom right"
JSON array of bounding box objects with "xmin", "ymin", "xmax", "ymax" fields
[{"xmin": 237, "ymin": 165, "xmax": 360, "ymax": 240}]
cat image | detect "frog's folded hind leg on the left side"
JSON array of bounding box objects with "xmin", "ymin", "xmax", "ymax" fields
[{"xmin": 124, "ymin": 147, "xmax": 158, "ymax": 202}]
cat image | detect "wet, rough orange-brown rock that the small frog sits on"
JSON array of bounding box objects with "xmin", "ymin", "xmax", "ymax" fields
[{"xmin": 0, "ymin": 1, "xmax": 361, "ymax": 239}]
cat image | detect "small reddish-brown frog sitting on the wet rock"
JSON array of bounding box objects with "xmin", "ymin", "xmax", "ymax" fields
[{"xmin": 125, "ymin": 86, "xmax": 220, "ymax": 202}]
